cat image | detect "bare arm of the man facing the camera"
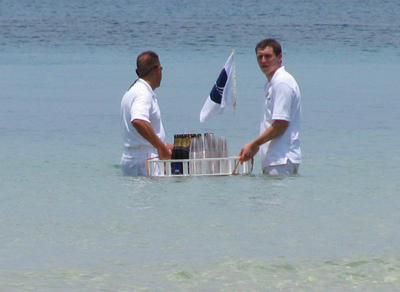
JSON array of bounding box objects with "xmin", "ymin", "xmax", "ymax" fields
[{"xmin": 239, "ymin": 120, "xmax": 289, "ymax": 162}]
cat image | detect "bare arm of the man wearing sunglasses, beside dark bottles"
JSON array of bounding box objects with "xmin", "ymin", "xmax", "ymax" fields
[{"xmin": 132, "ymin": 119, "xmax": 171, "ymax": 159}]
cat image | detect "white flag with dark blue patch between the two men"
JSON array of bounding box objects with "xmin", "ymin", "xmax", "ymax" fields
[{"xmin": 200, "ymin": 52, "xmax": 236, "ymax": 123}]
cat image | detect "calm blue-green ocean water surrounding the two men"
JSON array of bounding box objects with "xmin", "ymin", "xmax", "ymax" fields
[{"xmin": 0, "ymin": 0, "xmax": 400, "ymax": 292}]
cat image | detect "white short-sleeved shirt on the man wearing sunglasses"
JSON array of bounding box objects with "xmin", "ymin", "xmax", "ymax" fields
[{"xmin": 121, "ymin": 78, "xmax": 165, "ymax": 153}]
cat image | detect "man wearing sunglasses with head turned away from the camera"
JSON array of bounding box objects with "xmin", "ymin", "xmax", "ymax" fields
[{"xmin": 121, "ymin": 51, "xmax": 172, "ymax": 175}]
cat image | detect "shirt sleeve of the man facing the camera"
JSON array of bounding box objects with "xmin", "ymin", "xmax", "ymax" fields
[{"xmin": 272, "ymin": 82, "xmax": 293, "ymax": 122}]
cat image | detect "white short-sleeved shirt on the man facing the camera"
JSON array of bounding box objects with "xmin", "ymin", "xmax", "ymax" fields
[{"xmin": 260, "ymin": 66, "xmax": 301, "ymax": 168}]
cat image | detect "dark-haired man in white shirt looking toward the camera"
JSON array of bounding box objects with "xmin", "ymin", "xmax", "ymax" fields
[{"xmin": 239, "ymin": 39, "xmax": 301, "ymax": 175}]
